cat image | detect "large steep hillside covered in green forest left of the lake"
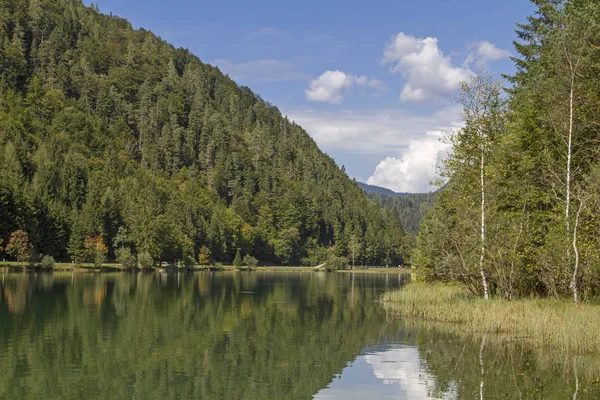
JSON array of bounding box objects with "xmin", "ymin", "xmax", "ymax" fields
[{"xmin": 0, "ymin": 0, "xmax": 403, "ymax": 265}]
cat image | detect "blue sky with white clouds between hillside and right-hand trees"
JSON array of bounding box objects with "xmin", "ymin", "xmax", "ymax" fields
[{"xmin": 85, "ymin": 0, "xmax": 534, "ymax": 192}]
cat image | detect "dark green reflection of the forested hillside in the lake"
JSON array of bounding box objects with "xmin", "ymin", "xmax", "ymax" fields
[{"xmin": 0, "ymin": 272, "xmax": 404, "ymax": 400}]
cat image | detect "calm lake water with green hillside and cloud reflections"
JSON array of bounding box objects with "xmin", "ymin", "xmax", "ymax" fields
[{"xmin": 0, "ymin": 272, "xmax": 600, "ymax": 400}]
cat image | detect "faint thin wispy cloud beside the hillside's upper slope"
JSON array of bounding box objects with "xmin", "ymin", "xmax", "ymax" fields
[{"xmin": 214, "ymin": 59, "xmax": 308, "ymax": 83}]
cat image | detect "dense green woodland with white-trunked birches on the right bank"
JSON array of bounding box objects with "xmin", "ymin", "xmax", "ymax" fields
[{"xmin": 413, "ymin": 0, "xmax": 600, "ymax": 302}]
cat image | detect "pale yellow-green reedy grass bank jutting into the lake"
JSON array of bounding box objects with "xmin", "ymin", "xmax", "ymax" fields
[{"xmin": 382, "ymin": 282, "xmax": 600, "ymax": 354}]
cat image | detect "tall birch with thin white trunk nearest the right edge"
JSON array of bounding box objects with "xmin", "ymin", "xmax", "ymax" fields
[{"xmin": 539, "ymin": 4, "xmax": 597, "ymax": 303}]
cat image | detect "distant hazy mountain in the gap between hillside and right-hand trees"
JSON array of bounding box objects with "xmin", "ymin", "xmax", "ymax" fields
[{"xmin": 358, "ymin": 182, "xmax": 437, "ymax": 235}]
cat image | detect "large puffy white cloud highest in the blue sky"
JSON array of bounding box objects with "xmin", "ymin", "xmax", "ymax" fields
[{"xmin": 381, "ymin": 32, "xmax": 472, "ymax": 102}]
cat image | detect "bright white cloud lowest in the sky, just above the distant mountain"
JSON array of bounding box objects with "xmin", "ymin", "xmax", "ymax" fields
[{"xmin": 367, "ymin": 131, "xmax": 451, "ymax": 193}]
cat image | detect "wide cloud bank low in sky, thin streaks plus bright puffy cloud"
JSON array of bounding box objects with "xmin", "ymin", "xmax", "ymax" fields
[{"xmin": 289, "ymin": 104, "xmax": 461, "ymax": 192}]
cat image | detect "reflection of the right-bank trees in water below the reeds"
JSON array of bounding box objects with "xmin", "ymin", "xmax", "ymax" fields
[{"xmin": 394, "ymin": 320, "xmax": 600, "ymax": 399}]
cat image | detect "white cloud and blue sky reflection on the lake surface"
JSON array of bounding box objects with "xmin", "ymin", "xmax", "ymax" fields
[{"xmin": 315, "ymin": 346, "xmax": 456, "ymax": 400}]
